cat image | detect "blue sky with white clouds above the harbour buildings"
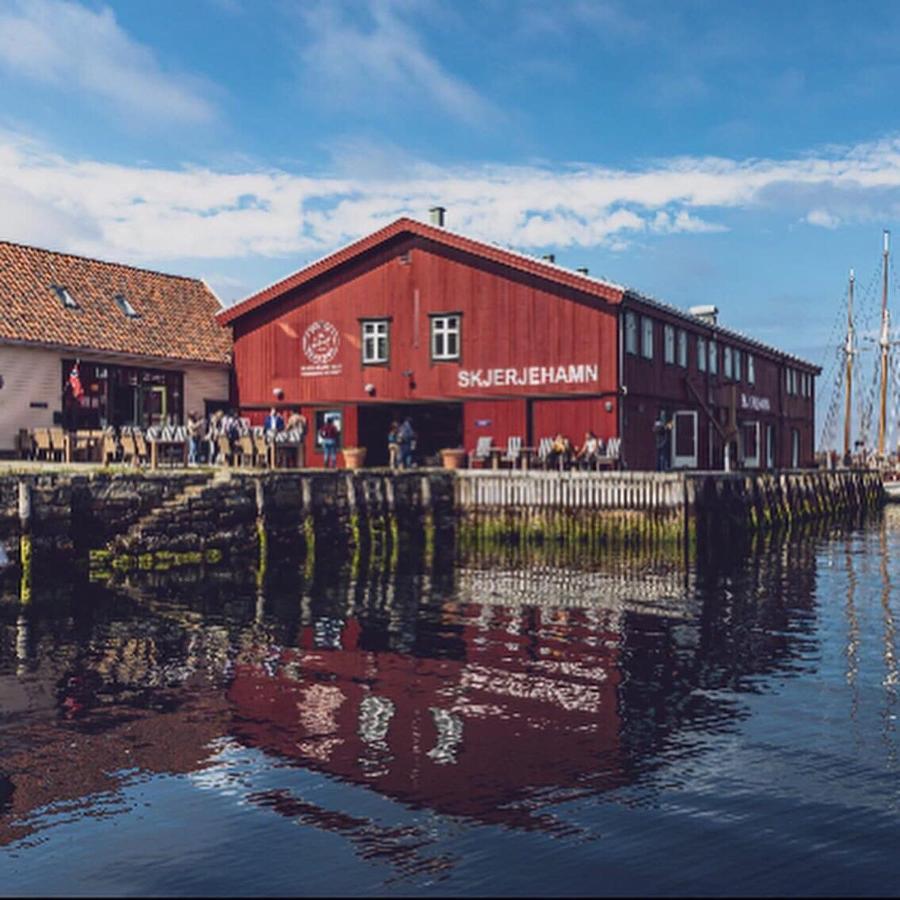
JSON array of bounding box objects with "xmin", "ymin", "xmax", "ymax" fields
[{"xmin": 0, "ymin": 0, "xmax": 900, "ymax": 414}]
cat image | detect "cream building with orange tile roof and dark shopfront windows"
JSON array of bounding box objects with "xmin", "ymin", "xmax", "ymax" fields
[{"xmin": 0, "ymin": 241, "xmax": 231, "ymax": 454}]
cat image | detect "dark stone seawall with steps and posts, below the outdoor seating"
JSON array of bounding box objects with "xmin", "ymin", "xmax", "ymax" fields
[{"xmin": 0, "ymin": 470, "xmax": 454, "ymax": 561}]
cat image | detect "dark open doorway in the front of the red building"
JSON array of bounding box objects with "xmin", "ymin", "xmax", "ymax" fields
[{"xmin": 357, "ymin": 403, "xmax": 463, "ymax": 466}]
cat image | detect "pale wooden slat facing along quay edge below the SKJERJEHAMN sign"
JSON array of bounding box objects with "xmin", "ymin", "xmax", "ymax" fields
[{"xmin": 456, "ymin": 469, "xmax": 688, "ymax": 510}]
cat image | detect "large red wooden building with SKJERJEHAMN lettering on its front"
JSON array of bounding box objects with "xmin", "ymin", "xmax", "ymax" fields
[{"xmin": 219, "ymin": 211, "xmax": 819, "ymax": 469}]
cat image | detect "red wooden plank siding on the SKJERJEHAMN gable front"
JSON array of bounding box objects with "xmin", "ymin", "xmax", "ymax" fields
[{"xmin": 234, "ymin": 235, "xmax": 617, "ymax": 458}]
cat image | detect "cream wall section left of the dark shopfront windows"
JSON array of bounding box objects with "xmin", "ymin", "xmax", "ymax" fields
[{"xmin": 0, "ymin": 346, "xmax": 62, "ymax": 452}]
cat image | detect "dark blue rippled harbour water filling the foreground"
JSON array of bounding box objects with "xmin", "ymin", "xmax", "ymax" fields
[{"xmin": 0, "ymin": 511, "xmax": 900, "ymax": 895}]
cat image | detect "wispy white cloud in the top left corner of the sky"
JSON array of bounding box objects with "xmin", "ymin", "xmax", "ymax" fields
[{"xmin": 0, "ymin": 0, "xmax": 213, "ymax": 122}]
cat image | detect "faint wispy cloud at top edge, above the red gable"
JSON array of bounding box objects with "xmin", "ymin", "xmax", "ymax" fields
[{"xmin": 301, "ymin": 0, "xmax": 500, "ymax": 125}]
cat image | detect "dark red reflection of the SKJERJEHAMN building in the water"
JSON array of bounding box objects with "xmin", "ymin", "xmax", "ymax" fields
[{"xmin": 228, "ymin": 607, "xmax": 623, "ymax": 826}]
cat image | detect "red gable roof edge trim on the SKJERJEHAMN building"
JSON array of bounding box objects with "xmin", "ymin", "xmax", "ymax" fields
[{"xmin": 218, "ymin": 218, "xmax": 624, "ymax": 325}]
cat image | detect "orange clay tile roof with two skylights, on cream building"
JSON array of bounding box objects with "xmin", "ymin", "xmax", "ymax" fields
[{"xmin": 0, "ymin": 241, "xmax": 232, "ymax": 363}]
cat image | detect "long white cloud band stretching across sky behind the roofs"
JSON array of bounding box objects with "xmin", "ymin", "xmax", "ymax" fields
[{"xmin": 0, "ymin": 132, "xmax": 900, "ymax": 272}]
